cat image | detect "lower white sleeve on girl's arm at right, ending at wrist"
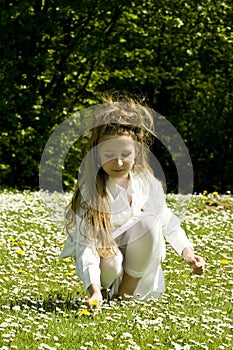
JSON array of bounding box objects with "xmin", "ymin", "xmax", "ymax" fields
[{"xmin": 161, "ymin": 206, "xmax": 193, "ymax": 256}]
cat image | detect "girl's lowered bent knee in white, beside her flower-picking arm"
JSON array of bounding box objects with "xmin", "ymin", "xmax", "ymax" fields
[{"xmin": 100, "ymin": 250, "xmax": 123, "ymax": 288}]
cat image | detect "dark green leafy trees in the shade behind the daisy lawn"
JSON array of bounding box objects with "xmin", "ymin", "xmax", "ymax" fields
[{"xmin": 0, "ymin": 0, "xmax": 233, "ymax": 192}]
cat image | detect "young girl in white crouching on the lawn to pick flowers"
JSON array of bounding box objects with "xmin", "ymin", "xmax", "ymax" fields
[{"xmin": 61, "ymin": 101, "xmax": 204, "ymax": 307}]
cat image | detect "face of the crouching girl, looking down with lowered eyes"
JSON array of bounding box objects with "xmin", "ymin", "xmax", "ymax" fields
[{"xmin": 99, "ymin": 136, "xmax": 136, "ymax": 183}]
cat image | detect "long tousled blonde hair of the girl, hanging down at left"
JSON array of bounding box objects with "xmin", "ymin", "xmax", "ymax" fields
[{"xmin": 66, "ymin": 99, "xmax": 153, "ymax": 257}]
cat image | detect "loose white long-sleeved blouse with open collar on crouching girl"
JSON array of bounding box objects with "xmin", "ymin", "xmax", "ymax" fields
[{"xmin": 60, "ymin": 171, "xmax": 192, "ymax": 299}]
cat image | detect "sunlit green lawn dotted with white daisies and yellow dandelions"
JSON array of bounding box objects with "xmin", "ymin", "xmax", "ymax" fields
[{"xmin": 0, "ymin": 191, "xmax": 233, "ymax": 350}]
